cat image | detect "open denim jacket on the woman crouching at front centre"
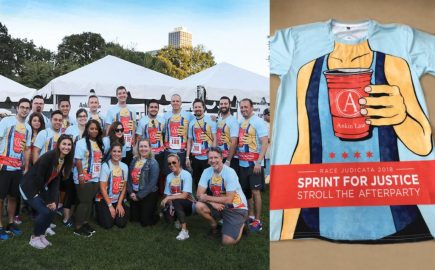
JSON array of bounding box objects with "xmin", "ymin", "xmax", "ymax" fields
[{"xmin": 127, "ymin": 158, "xmax": 160, "ymax": 199}]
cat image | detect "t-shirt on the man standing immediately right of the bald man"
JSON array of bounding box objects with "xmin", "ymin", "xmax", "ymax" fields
[{"xmin": 188, "ymin": 115, "xmax": 216, "ymax": 160}]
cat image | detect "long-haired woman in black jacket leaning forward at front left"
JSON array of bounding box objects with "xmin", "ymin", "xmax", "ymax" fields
[{"xmin": 20, "ymin": 135, "xmax": 74, "ymax": 249}]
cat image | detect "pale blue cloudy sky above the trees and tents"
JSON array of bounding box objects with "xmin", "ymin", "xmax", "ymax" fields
[{"xmin": 0, "ymin": 0, "xmax": 269, "ymax": 77}]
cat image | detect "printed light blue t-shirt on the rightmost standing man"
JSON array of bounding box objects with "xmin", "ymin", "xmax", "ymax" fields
[{"xmin": 238, "ymin": 115, "xmax": 268, "ymax": 167}]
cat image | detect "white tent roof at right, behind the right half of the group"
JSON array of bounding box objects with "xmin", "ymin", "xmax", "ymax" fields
[{"xmin": 171, "ymin": 63, "xmax": 270, "ymax": 102}]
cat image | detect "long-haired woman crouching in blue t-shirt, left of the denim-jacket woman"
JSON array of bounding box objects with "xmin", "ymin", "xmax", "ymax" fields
[{"xmin": 97, "ymin": 141, "xmax": 129, "ymax": 229}]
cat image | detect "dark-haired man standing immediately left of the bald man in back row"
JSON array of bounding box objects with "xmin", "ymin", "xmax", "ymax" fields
[{"xmin": 136, "ymin": 99, "xmax": 165, "ymax": 171}]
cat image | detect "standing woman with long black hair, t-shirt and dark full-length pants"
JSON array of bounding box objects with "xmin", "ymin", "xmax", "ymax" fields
[{"xmin": 73, "ymin": 119, "xmax": 104, "ymax": 237}]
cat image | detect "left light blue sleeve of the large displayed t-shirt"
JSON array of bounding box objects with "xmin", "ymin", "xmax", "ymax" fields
[{"xmin": 270, "ymin": 28, "xmax": 294, "ymax": 75}]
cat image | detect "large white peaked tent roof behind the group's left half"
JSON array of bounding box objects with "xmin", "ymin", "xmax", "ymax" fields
[{"xmin": 38, "ymin": 55, "xmax": 179, "ymax": 99}]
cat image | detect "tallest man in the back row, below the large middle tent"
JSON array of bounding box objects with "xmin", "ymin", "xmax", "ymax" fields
[{"xmin": 105, "ymin": 86, "xmax": 136, "ymax": 166}]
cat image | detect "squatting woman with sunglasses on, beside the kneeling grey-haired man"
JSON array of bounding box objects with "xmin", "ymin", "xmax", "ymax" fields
[{"xmin": 161, "ymin": 153, "xmax": 193, "ymax": 241}]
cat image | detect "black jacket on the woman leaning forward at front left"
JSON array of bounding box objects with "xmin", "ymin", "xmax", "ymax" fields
[{"xmin": 20, "ymin": 150, "xmax": 62, "ymax": 204}]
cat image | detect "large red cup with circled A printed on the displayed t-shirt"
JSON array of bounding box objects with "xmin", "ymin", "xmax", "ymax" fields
[{"xmin": 324, "ymin": 68, "xmax": 373, "ymax": 140}]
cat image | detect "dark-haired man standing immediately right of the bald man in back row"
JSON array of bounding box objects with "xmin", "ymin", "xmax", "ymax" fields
[{"xmin": 186, "ymin": 99, "xmax": 216, "ymax": 186}]
